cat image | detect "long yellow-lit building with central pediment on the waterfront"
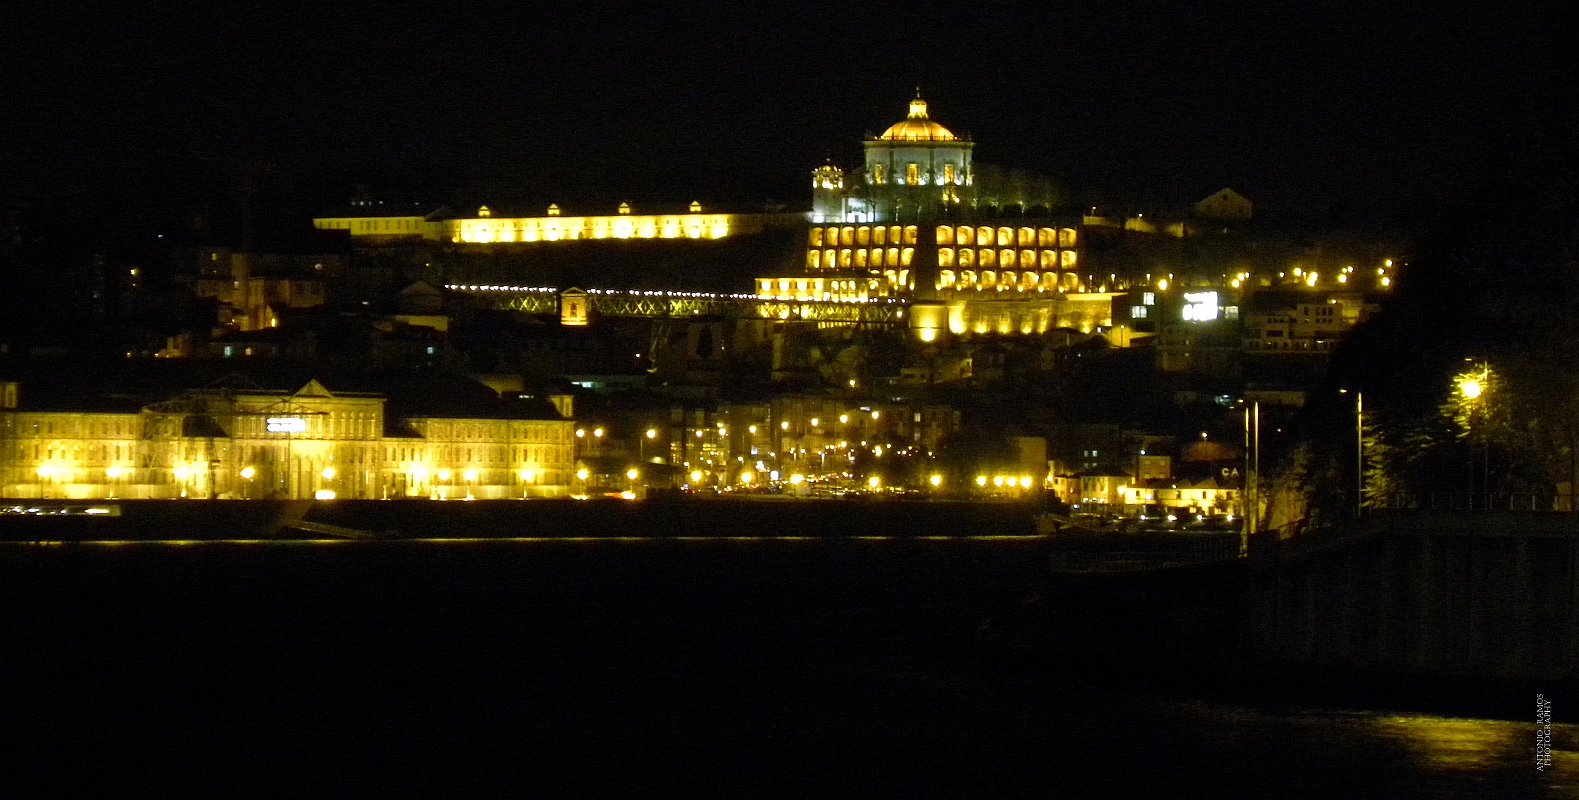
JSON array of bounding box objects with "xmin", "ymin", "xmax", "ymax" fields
[{"xmin": 0, "ymin": 380, "xmax": 573, "ymax": 499}]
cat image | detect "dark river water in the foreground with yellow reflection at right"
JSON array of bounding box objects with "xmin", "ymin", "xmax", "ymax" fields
[{"xmin": 0, "ymin": 538, "xmax": 1579, "ymax": 798}]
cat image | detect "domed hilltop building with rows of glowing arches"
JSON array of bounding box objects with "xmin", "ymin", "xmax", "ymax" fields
[{"xmin": 755, "ymin": 98, "xmax": 1127, "ymax": 344}]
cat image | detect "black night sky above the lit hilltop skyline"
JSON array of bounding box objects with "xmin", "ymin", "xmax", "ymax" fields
[{"xmin": 0, "ymin": 0, "xmax": 1571, "ymax": 235}]
